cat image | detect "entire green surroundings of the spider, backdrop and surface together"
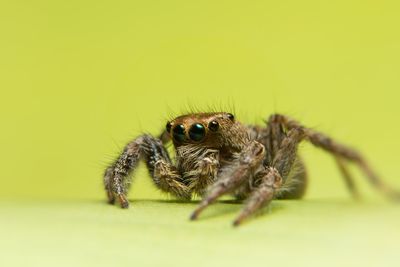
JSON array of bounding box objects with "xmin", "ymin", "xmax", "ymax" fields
[{"xmin": 0, "ymin": 0, "xmax": 400, "ymax": 266}]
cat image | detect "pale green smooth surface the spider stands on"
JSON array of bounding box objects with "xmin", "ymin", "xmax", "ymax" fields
[{"xmin": 0, "ymin": 200, "xmax": 400, "ymax": 267}]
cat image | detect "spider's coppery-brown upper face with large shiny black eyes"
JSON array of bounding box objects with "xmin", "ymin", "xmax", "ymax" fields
[{"xmin": 166, "ymin": 112, "xmax": 237, "ymax": 147}]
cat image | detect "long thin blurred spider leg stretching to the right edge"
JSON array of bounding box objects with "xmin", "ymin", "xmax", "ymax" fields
[{"xmin": 272, "ymin": 114, "xmax": 400, "ymax": 200}]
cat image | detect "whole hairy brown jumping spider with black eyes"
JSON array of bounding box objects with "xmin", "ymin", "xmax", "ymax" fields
[{"xmin": 104, "ymin": 112, "xmax": 399, "ymax": 225}]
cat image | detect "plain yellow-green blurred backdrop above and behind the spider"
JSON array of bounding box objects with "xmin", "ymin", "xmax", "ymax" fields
[{"xmin": 0, "ymin": 0, "xmax": 400, "ymax": 267}]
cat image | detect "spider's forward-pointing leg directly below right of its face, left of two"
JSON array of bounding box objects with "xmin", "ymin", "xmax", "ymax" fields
[{"xmin": 190, "ymin": 141, "xmax": 265, "ymax": 220}]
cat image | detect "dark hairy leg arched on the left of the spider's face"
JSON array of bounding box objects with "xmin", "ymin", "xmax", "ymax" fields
[{"xmin": 104, "ymin": 134, "xmax": 191, "ymax": 208}]
